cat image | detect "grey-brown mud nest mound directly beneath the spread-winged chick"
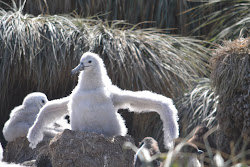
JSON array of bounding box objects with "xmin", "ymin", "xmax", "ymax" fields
[{"xmin": 49, "ymin": 129, "xmax": 134, "ymax": 167}]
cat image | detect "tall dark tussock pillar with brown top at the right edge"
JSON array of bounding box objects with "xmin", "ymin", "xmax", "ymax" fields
[{"xmin": 211, "ymin": 38, "xmax": 250, "ymax": 154}]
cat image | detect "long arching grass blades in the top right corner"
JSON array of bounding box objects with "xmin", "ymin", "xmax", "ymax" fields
[{"xmin": 191, "ymin": 0, "xmax": 250, "ymax": 42}]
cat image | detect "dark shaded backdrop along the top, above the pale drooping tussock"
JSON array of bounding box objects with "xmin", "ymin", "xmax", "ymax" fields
[{"xmin": 0, "ymin": 0, "xmax": 205, "ymax": 34}]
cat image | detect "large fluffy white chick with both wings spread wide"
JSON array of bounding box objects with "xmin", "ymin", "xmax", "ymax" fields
[{"xmin": 27, "ymin": 52, "xmax": 179, "ymax": 148}]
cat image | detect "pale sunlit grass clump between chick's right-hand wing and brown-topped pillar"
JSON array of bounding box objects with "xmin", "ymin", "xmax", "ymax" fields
[{"xmin": 176, "ymin": 78, "xmax": 217, "ymax": 137}]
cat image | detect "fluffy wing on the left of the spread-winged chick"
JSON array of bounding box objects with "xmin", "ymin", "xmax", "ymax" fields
[{"xmin": 27, "ymin": 96, "xmax": 70, "ymax": 148}]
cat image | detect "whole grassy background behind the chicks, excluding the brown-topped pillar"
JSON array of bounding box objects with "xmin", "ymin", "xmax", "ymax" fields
[{"xmin": 0, "ymin": 0, "xmax": 250, "ymax": 164}]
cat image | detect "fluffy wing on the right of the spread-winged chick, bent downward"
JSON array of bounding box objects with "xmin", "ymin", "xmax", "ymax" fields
[{"xmin": 110, "ymin": 86, "xmax": 179, "ymax": 148}]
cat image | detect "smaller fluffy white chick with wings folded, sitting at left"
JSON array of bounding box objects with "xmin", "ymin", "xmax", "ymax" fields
[{"xmin": 3, "ymin": 92, "xmax": 48, "ymax": 142}]
